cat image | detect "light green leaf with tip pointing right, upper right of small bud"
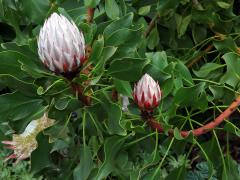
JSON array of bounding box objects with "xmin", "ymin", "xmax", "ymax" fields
[{"xmin": 193, "ymin": 63, "xmax": 224, "ymax": 78}]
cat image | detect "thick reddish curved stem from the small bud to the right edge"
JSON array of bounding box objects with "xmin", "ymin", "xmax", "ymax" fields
[{"xmin": 147, "ymin": 96, "xmax": 240, "ymax": 137}]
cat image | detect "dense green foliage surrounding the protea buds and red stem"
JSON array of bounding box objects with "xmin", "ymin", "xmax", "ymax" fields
[{"xmin": 0, "ymin": 0, "xmax": 240, "ymax": 180}]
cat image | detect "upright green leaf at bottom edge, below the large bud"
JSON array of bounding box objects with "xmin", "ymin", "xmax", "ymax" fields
[{"xmin": 73, "ymin": 146, "xmax": 93, "ymax": 180}]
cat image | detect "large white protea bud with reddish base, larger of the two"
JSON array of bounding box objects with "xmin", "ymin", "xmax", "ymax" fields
[{"xmin": 38, "ymin": 13, "xmax": 85, "ymax": 73}]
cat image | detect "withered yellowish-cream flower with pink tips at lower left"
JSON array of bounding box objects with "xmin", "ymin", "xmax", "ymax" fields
[{"xmin": 2, "ymin": 113, "xmax": 55, "ymax": 164}]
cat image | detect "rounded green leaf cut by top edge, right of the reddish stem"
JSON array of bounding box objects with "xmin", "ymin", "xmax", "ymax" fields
[{"xmin": 105, "ymin": 0, "xmax": 120, "ymax": 19}]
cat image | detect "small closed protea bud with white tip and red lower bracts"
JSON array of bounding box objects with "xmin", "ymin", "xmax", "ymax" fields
[{"xmin": 133, "ymin": 74, "xmax": 161, "ymax": 110}]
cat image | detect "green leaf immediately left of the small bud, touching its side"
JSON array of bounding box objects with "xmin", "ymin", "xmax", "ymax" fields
[{"xmin": 113, "ymin": 78, "xmax": 132, "ymax": 97}]
